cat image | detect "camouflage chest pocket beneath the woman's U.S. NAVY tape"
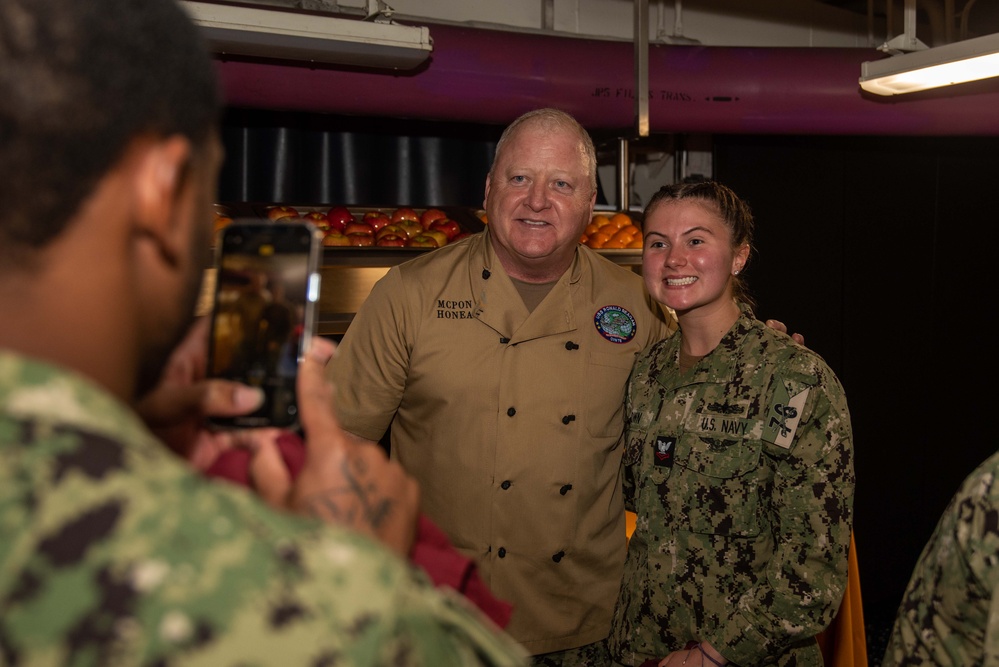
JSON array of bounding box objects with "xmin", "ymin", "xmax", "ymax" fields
[{"xmin": 668, "ymin": 427, "xmax": 770, "ymax": 537}]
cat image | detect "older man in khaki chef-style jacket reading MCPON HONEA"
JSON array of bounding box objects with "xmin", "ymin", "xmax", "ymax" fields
[{"xmin": 330, "ymin": 109, "xmax": 672, "ymax": 665}]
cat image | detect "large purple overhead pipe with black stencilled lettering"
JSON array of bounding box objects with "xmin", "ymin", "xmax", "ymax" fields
[{"xmin": 218, "ymin": 25, "xmax": 999, "ymax": 136}]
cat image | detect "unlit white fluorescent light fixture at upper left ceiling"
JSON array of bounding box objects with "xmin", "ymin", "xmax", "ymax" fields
[{"xmin": 180, "ymin": 0, "xmax": 433, "ymax": 69}]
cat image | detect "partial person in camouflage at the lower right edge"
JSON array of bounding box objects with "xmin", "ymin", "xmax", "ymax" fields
[{"xmin": 883, "ymin": 453, "xmax": 999, "ymax": 667}]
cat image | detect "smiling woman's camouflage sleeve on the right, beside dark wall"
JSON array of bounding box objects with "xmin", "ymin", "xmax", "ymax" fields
[{"xmin": 708, "ymin": 367, "xmax": 854, "ymax": 664}]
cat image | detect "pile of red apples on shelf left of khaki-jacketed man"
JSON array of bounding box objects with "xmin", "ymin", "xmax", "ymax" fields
[{"xmin": 262, "ymin": 204, "xmax": 471, "ymax": 249}]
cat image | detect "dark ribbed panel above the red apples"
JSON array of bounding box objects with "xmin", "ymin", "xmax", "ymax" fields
[{"xmin": 219, "ymin": 109, "xmax": 502, "ymax": 207}]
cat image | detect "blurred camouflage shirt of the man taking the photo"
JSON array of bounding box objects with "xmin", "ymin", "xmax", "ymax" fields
[{"xmin": 0, "ymin": 351, "xmax": 526, "ymax": 667}]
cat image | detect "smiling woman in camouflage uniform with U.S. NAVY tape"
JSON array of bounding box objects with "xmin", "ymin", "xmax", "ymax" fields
[{"xmin": 609, "ymin": 182, "xmax": 854, "ymax": 667}]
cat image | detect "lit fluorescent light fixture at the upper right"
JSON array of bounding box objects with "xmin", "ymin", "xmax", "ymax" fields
[{"xmin": 860, "ymin": 33, "xmax": 999, "ymax": 95}]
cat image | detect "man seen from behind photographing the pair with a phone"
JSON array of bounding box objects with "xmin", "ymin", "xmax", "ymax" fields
[{"xmin": 0, "ymin": 0, "xmax": 526, "ymax": 667}]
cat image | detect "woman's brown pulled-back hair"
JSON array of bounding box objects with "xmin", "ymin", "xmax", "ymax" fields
[{"xmin": 642, "ymin": 179, "xmax": 756, "ymax": 307}]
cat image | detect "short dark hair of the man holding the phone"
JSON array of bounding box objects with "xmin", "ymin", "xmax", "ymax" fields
[{"xmin": 0, "ymin": 0, "xmax": 221, "ymax": 259}]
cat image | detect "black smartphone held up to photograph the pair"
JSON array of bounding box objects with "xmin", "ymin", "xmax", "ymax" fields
[{"xmin": 208, "ymin": 219, "xmax": 322, "ymax": 429}]
